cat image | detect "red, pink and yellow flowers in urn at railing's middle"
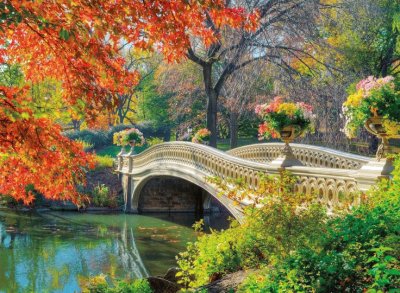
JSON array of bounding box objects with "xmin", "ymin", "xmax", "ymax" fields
[{"xmin": 255, "ymin": 97, "xmax": 313, "ymax": 139}]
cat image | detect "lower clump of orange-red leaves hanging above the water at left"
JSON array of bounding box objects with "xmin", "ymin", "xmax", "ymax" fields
[{"xmin": 0, "ymin": 87, "xmax": 93, "ymax": 204}]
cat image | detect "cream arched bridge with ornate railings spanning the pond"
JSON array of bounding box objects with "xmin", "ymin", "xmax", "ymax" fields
[{"xmin": 117, "ymin": 142, "xmax": 391, "ymax": 221}]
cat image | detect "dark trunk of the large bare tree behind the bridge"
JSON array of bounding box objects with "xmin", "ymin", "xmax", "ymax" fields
[{"xmin": 203, "ymin": 64, "xmax": 218, "ymax": 148}]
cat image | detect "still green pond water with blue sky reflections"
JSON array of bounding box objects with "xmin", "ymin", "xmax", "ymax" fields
[{"xmin": 0, "ymin": 209, "xmax": 227, "ymax": 293}]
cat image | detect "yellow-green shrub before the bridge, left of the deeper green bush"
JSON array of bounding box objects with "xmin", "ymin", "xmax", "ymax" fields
[{"xmin": 177, "ymin": 174, "xmax": 327, "ymax": 287}]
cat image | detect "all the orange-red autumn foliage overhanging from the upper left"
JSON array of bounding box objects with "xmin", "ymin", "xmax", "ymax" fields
[{"xmin": 0, "ymin": 0, "xmax": 255, "ymax": 204}]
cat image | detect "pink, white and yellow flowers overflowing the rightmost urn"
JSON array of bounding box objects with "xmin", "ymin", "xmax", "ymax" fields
[{"xmin": 343, "ymin": 76, "xmax": 400, "ymax": 138}]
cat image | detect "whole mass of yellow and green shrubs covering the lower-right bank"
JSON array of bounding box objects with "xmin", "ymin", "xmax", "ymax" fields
[{"xmin": 177, "ymin": 159, "xmax": 400, "ymax": 292}]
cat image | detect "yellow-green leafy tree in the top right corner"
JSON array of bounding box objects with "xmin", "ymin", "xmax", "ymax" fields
[{"xmin": 321, "ymin": 0, "xmax": 400, "ymax": 78}]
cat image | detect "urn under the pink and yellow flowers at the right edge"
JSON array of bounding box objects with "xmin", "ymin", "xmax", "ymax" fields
[{"xmin": 364, "ymin": 116, "xmax": 400, "ymax": 161}]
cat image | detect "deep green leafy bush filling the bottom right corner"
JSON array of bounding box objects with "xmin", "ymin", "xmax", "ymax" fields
[{"xmin": 240, "ymin": 155, "xmax": 400, "ymax": 292}]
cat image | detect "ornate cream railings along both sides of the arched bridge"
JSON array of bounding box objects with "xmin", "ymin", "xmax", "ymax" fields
[{"xmin": 118, "ymin": 142, "xmax": 386, "ymax": 211}]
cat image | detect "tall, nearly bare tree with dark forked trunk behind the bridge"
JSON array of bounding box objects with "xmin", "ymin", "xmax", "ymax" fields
[{"xmin": 187, "ymin": 0, "xmax": 319, "ymax": 147}]
